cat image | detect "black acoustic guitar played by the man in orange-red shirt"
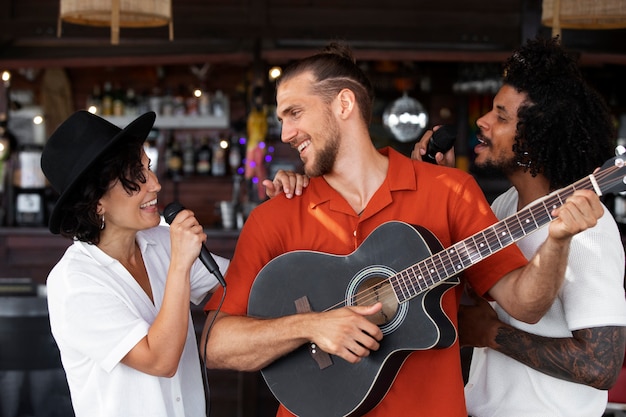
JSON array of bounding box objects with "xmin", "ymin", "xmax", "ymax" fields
[{"xmin": 248, "ymin": 156, "xmax": 626, "ymax": 417}]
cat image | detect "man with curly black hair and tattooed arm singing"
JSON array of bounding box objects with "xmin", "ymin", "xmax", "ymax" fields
[{"xmin": 413, "ymin": 38, "xmax": 626, "ymax": 417}]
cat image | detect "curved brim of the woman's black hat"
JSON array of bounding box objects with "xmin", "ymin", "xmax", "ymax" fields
[{"xmin": 48, "ymin": 112, "xmax": 156, "ymax": 234}]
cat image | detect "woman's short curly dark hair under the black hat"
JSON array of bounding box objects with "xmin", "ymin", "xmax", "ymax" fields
[{"xmin": 60, "ymin": 138, "xmax": 147, "ymax": 244}]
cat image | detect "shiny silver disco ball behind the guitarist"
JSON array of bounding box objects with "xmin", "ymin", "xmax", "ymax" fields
[{"xmin": 383, "ymin": 93, "xmax": 428, "ymax": 142}]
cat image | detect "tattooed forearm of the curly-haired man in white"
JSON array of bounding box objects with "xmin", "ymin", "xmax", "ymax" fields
[{"xmin": 495, "ymin": 324, "xmax": 626, "ymax": 390}]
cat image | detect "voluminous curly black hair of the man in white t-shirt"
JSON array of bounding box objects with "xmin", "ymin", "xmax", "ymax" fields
[{"xmin": 503, "ymin": 37, "xmax": 616, "ymax": 189}]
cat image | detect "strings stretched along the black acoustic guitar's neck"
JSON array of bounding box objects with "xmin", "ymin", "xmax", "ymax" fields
[{"xmin": 324, "ymin": 166, "xmax": 621, "ymax": 311}]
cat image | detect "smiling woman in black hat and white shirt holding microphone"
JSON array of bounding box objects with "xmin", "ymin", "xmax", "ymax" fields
[{"xmin": 41, "ymin": 111, "xmax": 302, "ymax": 417}]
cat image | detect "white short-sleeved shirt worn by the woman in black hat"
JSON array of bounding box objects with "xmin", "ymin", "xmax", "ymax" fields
[{"xmin": 47, "ymin": 226, "xmax": 228, "ymax": 417}]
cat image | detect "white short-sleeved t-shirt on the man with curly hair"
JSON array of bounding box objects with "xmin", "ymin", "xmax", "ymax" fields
[{"xmin": 465, "ymin": 188, "xmax": 626, "ymax": 417}]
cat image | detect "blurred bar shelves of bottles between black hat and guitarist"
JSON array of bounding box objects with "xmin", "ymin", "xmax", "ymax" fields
[{"xmin": 86, "ymin": 82, "xmax": 240, "ymax": 181}]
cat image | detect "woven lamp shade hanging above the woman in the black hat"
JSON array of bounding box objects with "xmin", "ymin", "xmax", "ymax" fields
[{"xmin": 58, "ymin": 0, "xmax": 174, "ymax": 45}]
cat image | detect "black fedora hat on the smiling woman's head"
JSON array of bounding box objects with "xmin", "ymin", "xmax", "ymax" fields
[{"xmin": 41, "ymin": 110, "xmax": 156, "ymax": 234}]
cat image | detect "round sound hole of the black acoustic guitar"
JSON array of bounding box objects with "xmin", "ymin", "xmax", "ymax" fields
[{"xmin": 354, "ymin": 277, "xmax": 398, "ymax": 326}]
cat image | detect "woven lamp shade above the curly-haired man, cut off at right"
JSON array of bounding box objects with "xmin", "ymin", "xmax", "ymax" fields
[{"xmin": 541, "ymin": 0, "xmax": 626, "ymax": 36}]
